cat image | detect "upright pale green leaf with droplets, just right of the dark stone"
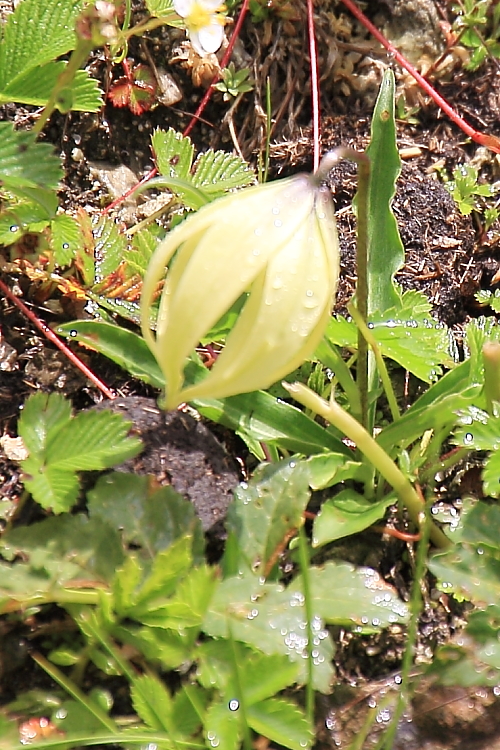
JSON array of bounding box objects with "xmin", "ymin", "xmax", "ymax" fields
[{"xmin": 226, "ymin": 461, "xmax": 310, "ymax": 575}]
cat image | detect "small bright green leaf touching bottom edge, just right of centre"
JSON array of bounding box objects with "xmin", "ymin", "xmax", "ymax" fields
[{"xmin": 247, "ymin": 698, "xmax": 314, "ymax": 750}]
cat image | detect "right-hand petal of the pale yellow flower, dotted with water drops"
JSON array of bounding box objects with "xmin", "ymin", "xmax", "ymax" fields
[{"xmin": 182, "ymin": 197, "xmax": 338, "ymax": 400}]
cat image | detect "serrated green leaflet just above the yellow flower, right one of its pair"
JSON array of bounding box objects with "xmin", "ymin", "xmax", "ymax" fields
[{"xmin": 193, "ymin": 149, "xmax": 255, "ymax": 198}]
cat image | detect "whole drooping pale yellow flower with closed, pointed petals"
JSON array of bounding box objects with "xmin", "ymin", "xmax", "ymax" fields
[{"xmin": 141, "ymin": 170, "xmax": 339, "ymax": 409}]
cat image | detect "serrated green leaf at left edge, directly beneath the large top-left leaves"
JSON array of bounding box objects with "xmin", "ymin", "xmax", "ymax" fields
[{"xmin": 0, "ymin": 122, "xmax": 63, "ymax": 190}]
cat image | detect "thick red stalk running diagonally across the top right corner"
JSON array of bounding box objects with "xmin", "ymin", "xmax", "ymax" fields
[{"xmin": 342, "ymin": 0, "xmax": 500, "ymax": 154}]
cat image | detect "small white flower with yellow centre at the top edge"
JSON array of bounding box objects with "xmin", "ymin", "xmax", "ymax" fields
[{"xmin": 174, "ymin": 0, "xmax": 226, "ymax": 57}]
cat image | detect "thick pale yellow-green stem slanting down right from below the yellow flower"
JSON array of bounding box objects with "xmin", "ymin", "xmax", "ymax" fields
[{"xmin": 282, "ymin": 382, "xmax": 451, "ymax": 549}]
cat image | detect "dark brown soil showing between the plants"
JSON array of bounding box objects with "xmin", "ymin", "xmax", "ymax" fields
[{"xmin": 0, "ymin": 0, "xmax": 500, "ymax": 750}]
